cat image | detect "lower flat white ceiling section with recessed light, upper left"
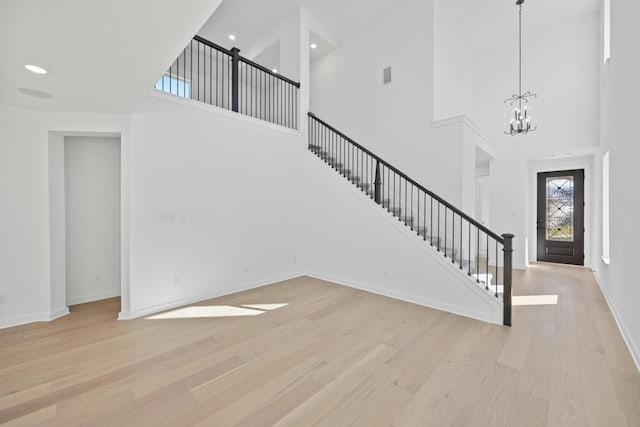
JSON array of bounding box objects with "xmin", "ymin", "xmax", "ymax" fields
[{"xmin": 0, "ymin": 0, "xmax": 221, "ymax": 113}]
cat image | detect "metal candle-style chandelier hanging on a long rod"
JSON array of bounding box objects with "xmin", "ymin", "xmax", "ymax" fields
[{"xmin": 504, "ymin": 0, "xmax": 538, "ymax": 136}]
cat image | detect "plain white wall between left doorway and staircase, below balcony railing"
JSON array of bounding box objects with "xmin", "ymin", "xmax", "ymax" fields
[{"xmin": 126, "ymin": 94, "xmax": 306, "ymax": 318}]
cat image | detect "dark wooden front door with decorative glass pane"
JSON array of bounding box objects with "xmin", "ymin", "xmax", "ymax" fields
[{"xmin": 537, "ymin": 169, "xmax": 584, "ymax": 265}]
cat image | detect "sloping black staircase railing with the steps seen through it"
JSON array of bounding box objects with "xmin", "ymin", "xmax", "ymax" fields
[{"xmin": 308, "ymin": 113, "xmax": 513, "ymax": 326}]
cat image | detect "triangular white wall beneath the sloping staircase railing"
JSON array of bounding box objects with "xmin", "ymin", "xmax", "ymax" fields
[{"xmin": 298, "ymin": 148, "xmax": 502, "ymax": 324}]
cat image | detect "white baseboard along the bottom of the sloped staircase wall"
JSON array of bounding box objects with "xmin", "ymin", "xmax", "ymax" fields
[{"xmin": 304, "ymin": 273, "xmax": 502, "ymax": 325}]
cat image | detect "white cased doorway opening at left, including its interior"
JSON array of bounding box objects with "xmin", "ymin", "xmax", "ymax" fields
[{"xmin": 49, "ymin": 131, "xmax": 123, "ymax": 319}]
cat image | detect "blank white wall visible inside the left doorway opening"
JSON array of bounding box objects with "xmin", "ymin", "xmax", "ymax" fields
[{"xmin": 64, "ymin": 136, "xmax": 120, "ymax": 305}]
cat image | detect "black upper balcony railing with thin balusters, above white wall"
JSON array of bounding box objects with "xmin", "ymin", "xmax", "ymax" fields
[{"xmin": 155, "ymin": 36, "xmax": 300, "ymax": 129}]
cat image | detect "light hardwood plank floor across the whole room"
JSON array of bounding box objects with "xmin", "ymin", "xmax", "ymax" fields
[{"xmin": 0, "ymin": 265, "xmax": 640, "ymax": 427}]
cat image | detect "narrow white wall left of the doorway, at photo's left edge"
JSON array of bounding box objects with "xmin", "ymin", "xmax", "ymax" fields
[{"xmin": 0, "ymin": 106, "xmax": 50, "ymax": 326}]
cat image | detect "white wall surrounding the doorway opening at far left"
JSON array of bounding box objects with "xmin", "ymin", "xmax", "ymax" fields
[{"xmin": 0, "ymin": 106, "xmax": 129, "ymax": 327}]
